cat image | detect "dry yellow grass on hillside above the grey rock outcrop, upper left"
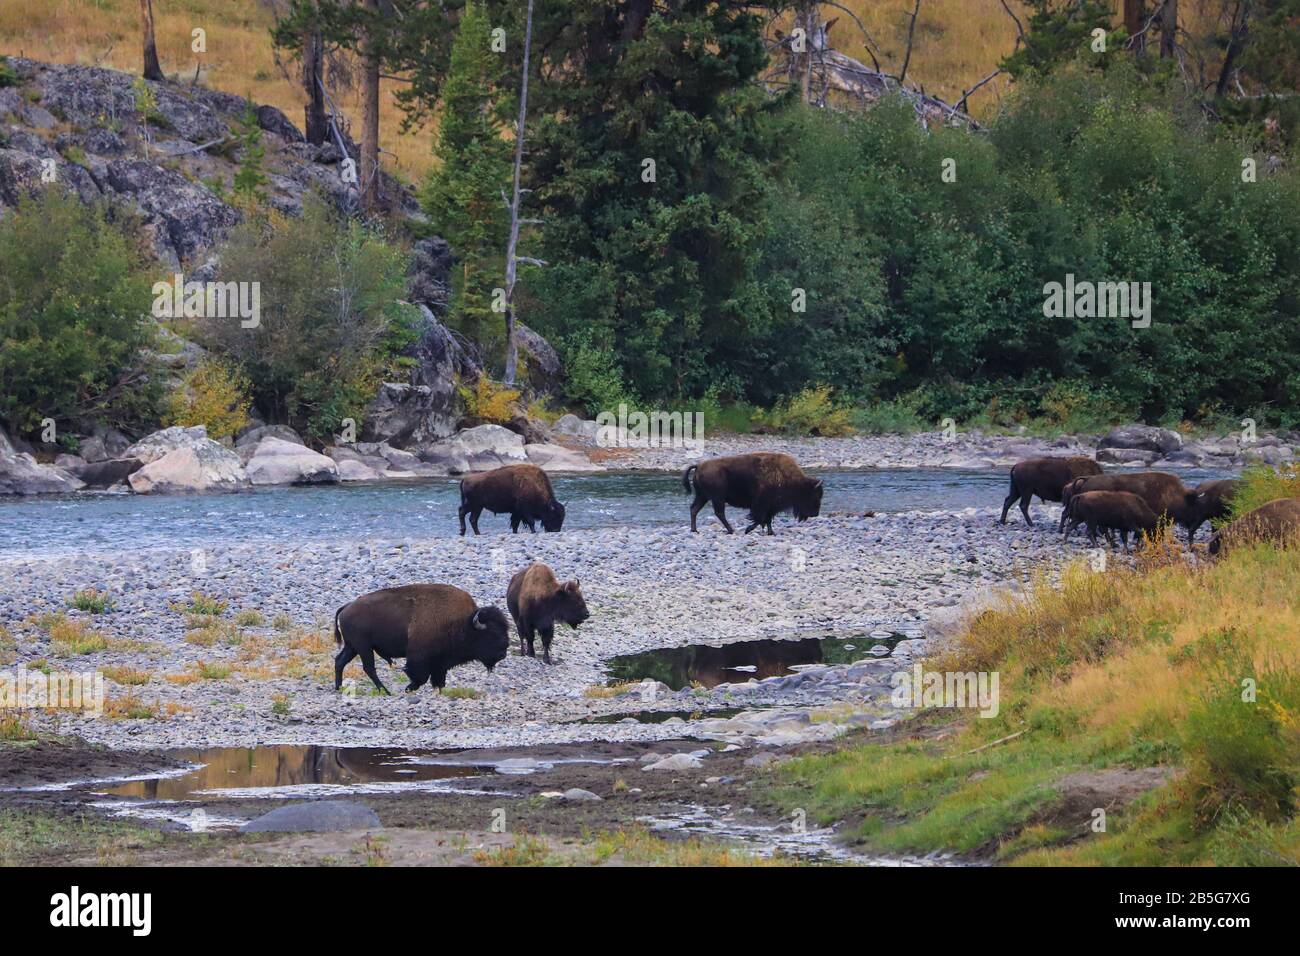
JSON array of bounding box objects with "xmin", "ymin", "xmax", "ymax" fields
[{"xmin": 0, "ymin": 0, "xmax": 433, "ymax": 179}]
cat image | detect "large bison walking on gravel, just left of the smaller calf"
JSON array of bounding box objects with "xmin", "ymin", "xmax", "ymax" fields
[{"xmin": 334, "ymin": 584, "xmax": 510, "ymax": 693}]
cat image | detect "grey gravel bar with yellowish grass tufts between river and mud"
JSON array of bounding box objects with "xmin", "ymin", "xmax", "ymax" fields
[{"xmin": 0, "ymin": 507, "xmax": 1078, "ymax": 748}]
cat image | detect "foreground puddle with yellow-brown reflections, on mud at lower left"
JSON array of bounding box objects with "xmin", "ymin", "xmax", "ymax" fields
[{"xmin": 101, "ymin": 744, "xmax": 493, "ymax": 800}]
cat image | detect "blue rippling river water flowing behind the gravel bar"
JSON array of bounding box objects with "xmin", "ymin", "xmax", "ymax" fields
[{"xmin": 0, "ymin": 468, "xmax": 1222, "ymax": 557}]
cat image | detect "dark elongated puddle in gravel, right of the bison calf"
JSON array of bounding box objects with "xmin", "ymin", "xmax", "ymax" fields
[{"xmin": 607, "ymin": 632, "xmax": 906, "ymax": 691}]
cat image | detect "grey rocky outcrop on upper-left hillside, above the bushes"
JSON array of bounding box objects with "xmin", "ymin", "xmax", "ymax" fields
[{"xmin": 0, "ymin": 57, "xmax": 420, "ymax": 268}]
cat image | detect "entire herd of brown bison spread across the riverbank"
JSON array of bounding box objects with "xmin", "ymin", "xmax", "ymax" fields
[{"xmin": 334, "ymin": 451, "xmax": 1300, "ymax": 693}]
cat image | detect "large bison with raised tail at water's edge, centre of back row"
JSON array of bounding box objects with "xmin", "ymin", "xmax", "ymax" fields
[{"xmin": 681, "ymin": 451, "xmax": 823, "ymax": 535}]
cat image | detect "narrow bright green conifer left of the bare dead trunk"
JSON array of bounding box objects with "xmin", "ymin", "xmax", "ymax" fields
[{"xmin": 421, "ymin": 3, "xmax": 510, "ymax": 354}]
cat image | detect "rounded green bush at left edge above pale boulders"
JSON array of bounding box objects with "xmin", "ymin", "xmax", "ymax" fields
[{"xmin": 0, "ymin": 190, "xmax": 159, "ymax": 433}]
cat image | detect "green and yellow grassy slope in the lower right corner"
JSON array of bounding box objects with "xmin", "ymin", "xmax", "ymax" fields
[{"xmin": 781, "ymin": 515, "xmax": 1300, "ymax": 865}]
